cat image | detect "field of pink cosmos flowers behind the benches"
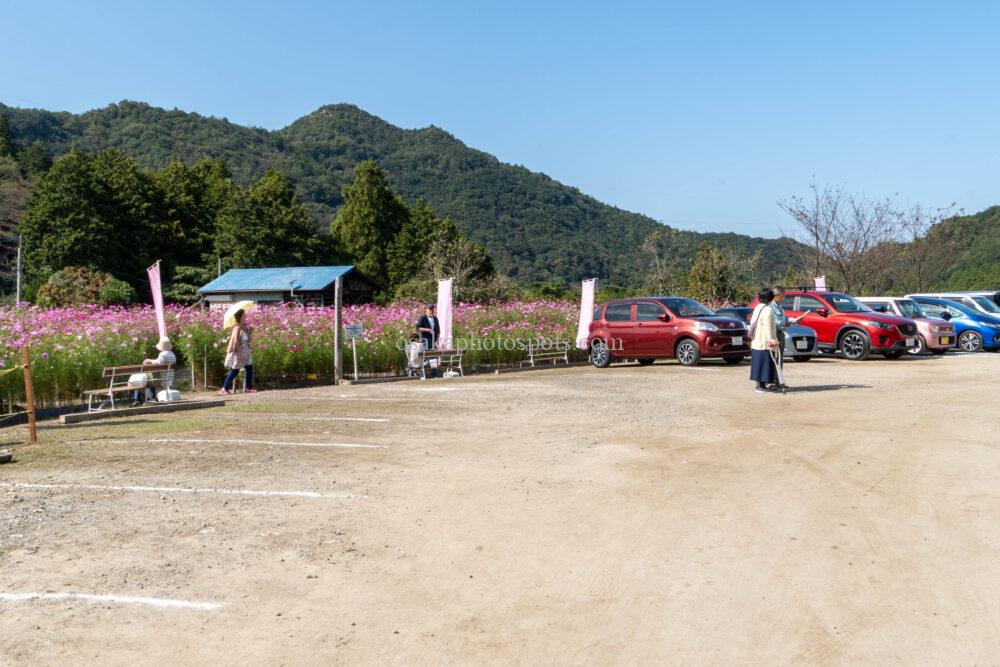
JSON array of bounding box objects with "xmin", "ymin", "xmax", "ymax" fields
[{"xmin": 0, "ymin": 301, "xmax": 582, "ymax": 411}]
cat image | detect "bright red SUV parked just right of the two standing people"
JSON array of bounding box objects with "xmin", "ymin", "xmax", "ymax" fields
[{"xmin": 750, "ymin": 291, "xmax": 919, "ymax": 361}]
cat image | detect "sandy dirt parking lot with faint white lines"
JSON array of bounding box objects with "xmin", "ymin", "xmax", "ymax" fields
[{"xmin": 0, "ymin": 354, "xmax": 1000, "ymax": 665}]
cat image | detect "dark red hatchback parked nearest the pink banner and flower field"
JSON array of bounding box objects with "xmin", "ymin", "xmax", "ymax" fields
[{"xmin": 587, "ymin": 296, "xmax": 749, "ymax": 368}]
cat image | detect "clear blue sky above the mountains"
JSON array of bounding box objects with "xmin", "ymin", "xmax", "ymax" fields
[{"xmin": 0, "ymin": 0, "xmax": 1000, "ymax": 236}]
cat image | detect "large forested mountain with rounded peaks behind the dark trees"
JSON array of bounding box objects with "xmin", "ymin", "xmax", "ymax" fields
[{"xmin": 0, "ymin": 101, "xmax": 796, "ymax": 285}]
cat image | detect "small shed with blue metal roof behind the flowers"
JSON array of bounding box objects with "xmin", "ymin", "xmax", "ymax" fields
[{"xmin": 198, "ymin": 266, "xmax": 377, "ymax": 307}]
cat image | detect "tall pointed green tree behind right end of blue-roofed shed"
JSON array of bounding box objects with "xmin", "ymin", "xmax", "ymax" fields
[{"xmin": 330, "ymin": 160, "xmax": 409, "ymax": 288}]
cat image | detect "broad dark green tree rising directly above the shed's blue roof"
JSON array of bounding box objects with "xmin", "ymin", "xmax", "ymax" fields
[{"xmin": 215, "ymin": 171, "xmax": 324, "ymax": 267}]
